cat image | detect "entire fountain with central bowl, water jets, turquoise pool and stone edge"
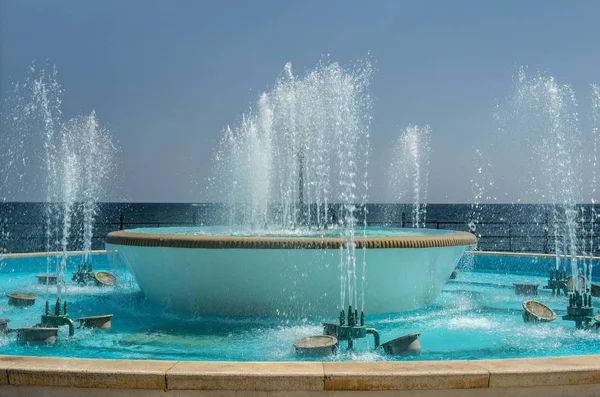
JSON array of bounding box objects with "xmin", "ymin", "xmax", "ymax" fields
[{"xmin": 5, "ymin": 58, "xmax": 600, "ymax": 394}]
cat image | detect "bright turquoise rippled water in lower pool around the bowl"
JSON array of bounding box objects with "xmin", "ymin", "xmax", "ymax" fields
[{"xmin": 0, "ymin": 252, "xmax": 600, "ymax": 361}]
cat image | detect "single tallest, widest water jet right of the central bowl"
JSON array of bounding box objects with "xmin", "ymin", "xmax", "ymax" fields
[{"xmin": 510, "ymin": 68, "xmax": 583, "ymax": 284}]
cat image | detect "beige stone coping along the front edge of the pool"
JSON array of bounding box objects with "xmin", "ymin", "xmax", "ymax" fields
[{"xmin": 0, "ymin": 355, "xmax": 600, "ymax": 395}]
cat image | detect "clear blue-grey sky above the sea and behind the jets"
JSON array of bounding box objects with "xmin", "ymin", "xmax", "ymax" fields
[{"xmin": 0, "ymin": 0, "xmax": 600, "ymax": 203}]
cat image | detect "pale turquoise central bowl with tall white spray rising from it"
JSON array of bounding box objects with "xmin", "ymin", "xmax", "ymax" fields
[{"xmin": 106, "ymin": 62, "xmax": 476, "ymax": 316}]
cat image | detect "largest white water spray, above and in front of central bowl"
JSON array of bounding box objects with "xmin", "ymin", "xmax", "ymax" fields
[{"xmin": 210, "ymin": 62, "xmax": 371, "ymax": 307}]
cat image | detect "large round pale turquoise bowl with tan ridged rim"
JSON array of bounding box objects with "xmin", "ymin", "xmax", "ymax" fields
[{"xmin": 106, "ymin": 228, "xmax": 476, "ymax": 316}]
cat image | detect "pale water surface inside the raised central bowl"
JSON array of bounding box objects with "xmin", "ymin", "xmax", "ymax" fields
[{"xmin": 127, "ymin": 226, "xmax": 453, "ymax": 238}]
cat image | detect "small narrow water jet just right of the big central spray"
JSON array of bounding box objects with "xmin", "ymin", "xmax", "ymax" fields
[{"xmin": 389, "ymin": 125, "xmax": 431, "ymax": 228}]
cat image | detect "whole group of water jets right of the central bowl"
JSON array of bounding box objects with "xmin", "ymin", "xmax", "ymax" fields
[{"xmin": 474, "ymin": 68, "xmax": 597, "ymax": 316}]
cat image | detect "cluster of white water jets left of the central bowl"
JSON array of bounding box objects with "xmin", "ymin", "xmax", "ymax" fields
[{"xmin": 0, "ymin": 64, "xmax": 115, "ymax": 298}]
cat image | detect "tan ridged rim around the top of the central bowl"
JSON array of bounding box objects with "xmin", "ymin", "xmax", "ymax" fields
[{"xmin": 106, "ymin": 230, "xmax": 477, "ymax": 249}]
